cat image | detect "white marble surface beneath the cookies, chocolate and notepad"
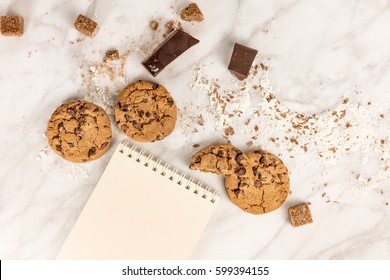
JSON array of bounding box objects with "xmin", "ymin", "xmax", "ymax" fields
[{"xmin": 0, "ymin": 0, "xmax": 390, "ymax": 259}]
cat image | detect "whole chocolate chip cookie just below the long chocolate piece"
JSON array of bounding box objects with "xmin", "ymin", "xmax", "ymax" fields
[{"xmin": 115, "ymin": 81, "xmax": 177, "ymax": 142}]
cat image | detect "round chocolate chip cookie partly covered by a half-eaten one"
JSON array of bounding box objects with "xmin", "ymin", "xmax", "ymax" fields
[{"xmin": 225, "ymin": 151, "xmax": 290, "ymax": 214}]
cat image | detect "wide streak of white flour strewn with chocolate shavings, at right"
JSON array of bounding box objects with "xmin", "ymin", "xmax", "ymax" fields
[{"xmin": 190, "ymin": 64, "xmax": 390, "ymax": 197}]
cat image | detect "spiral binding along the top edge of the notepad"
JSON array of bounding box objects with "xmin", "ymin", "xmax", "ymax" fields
[{"xmin": 119, "ymin": 142, "xmax": 217, "ymax": 203}]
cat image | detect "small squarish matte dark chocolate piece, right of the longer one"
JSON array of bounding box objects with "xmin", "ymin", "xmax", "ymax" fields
[{"xmin": 228, "ymin": 43, "xmax": 257, "ymax": 80}]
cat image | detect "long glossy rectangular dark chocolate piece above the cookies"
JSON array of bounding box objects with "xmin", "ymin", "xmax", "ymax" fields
[{"xmin": 141, "ymin": 30, "xmax": 199, "ymax": 77}]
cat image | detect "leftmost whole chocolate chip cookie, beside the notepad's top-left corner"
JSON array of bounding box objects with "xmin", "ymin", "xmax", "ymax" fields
[{"xmin": 47, "ymin": 100, "xmax": 112, "ymax": 162}]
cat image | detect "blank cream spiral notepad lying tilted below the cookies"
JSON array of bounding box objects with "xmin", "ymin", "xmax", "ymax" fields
[{"xmin": 57, "ymin": 143, "xmax": 219, "ymax": 259}]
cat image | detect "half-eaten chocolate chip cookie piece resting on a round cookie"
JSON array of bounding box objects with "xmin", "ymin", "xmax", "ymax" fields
[{"xmin": 189, "ymin": 144, "xmax": 245, "ymax": 176}]
